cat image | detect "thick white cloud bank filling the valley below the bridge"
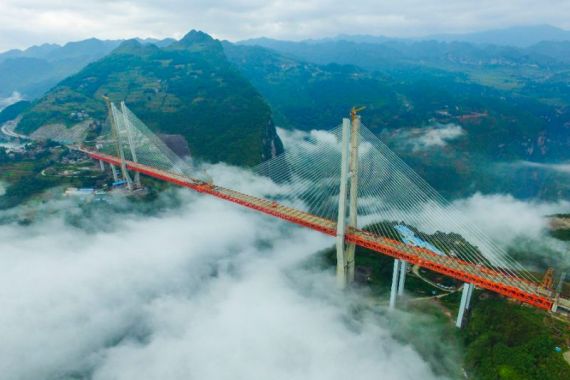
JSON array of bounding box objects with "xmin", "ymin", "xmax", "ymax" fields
[{"xmin": 0, "ymin": 167, "xmax": 452, "ymax": 380}]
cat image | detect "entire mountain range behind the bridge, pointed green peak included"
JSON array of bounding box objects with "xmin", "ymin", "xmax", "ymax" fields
[{"xmin": 0, "ymin": 26, "xmax": 570, "ymax": 198}]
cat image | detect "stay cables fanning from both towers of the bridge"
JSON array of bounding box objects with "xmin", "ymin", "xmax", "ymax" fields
[{"xmin": 93, "ymin": 103, "xmax": 538, "ymax": 293}]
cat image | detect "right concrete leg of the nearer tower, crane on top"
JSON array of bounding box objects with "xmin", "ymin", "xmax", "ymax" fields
[{"xmin": 346, "ymin": 115, "xmax": 360, "ymax": 284}]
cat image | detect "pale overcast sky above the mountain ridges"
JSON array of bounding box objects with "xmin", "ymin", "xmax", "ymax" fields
[{"xmin": 0, "ymin": 0, "xmax": 570, "ymax": 51}]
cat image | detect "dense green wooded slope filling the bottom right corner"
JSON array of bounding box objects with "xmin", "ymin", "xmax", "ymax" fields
[{"xmin": 463, "ymin": 296, "xmax": 570, "ymax": 380}]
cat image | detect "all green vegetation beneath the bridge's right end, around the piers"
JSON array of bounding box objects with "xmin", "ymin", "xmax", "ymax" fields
[{"xmin": 312, "ymin": 235, "xmax": 570, "ymax": 380}]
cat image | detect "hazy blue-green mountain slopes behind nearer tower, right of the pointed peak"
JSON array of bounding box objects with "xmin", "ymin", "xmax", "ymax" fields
[{"xmin": 224, "ymin": 40, "xmax": 570, "ymax": 198}]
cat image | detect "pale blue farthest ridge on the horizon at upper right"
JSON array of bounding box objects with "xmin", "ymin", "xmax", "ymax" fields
[{"xmin": 422, "ymin": 25, "xmax": 570, "ymax": 47}]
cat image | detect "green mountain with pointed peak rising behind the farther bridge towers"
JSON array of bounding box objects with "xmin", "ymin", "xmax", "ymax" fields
[{"xmin": 17, "ymin": 31, "xmax": 282, "ymax": 165}]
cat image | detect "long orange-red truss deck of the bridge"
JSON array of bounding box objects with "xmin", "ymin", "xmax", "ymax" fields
[{"xmin": 86, "ymin": 149, "xmax": 556, "ymax": 310}]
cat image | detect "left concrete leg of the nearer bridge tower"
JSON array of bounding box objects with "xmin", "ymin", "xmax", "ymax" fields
[{"xmin": 336, "ymin": 119, "xmax": 350, "ymax": 289}]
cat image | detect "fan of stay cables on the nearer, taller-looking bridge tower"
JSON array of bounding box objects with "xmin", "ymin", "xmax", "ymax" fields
[{"xmin": 254, "ymin": 125, "xmax": 538, "ymax": 290}]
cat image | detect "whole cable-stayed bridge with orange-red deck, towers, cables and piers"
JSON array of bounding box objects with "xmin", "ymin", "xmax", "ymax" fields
[{"xmin": 76, "ymin": 102, "xmax": 570, "ymax": 327}]
